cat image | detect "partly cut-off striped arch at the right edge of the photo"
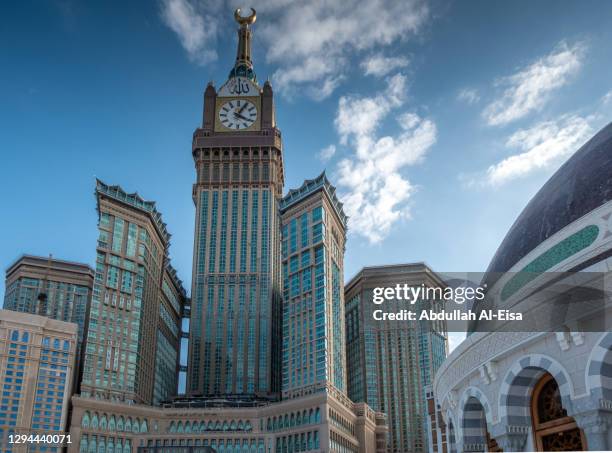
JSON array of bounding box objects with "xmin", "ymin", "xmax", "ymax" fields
[{"xmin": 585, "ymin": 332, "xmax": 612, "ymax": 401}]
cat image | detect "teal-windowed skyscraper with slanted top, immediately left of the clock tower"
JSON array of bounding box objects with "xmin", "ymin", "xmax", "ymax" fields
[{"xmin": 81, "ymin": 180, "xmax": 185, "ymax": 404}]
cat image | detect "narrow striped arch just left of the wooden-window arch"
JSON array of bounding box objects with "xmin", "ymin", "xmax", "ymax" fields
[{"xmin": 459, "ymin": 387, "xmax": 492, "ymax": 452}]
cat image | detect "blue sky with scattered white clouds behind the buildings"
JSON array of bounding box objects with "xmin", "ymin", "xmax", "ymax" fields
[{"xmin": 0, "ymin": 0, "xmax": 612, "ymax": 338}]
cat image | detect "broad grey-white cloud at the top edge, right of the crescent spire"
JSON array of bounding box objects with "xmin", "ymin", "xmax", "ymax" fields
[{"xmin": 254, "ymin": 0, "xmax": 429, "ymax": 99}]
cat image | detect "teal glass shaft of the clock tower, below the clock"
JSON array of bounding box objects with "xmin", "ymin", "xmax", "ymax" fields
[{"xmin": 188, "ymin": 182, "xmax": 278, "ymax": 395}]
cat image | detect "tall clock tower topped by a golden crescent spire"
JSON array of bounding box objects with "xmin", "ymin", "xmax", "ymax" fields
[{"xmin": 187, "ymin": 9, "xmax": 284, "ymax": 398}]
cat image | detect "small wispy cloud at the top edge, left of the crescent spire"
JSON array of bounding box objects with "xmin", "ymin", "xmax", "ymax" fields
[{"xmin": 161, "ymin": 0, "xmax": 217, "ymax": 65}]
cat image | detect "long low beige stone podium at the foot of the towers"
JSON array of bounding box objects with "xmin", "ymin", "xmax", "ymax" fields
[{"xmin": 68, "ymin": 393, "xmax": 386, "ymax": 453}]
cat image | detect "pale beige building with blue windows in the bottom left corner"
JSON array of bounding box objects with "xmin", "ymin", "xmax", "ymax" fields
[{"xmin": 0, "ymin": 310, "xmax": 78, "ymax": 453}]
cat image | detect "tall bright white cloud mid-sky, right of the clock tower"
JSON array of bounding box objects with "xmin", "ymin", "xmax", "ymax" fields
[{"xmin": 335, "ymin": 75, "xmax": 437, "ymax": 243}]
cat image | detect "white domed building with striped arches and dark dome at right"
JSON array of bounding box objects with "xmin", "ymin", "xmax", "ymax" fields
[{"xmin": 433, "ymin": 124, "xmax": 612, "ymax": 453}]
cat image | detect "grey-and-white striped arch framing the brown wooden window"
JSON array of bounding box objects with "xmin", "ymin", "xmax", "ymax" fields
[{"xmin": 499, "ymin": 354, "xmax": 574, "ymax": 429}]
